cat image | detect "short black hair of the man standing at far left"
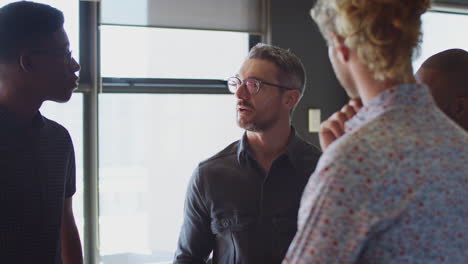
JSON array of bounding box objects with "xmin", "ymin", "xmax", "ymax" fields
[{"xmin": 0, "ymin": 1, "xmax": 64, "ymax": 62}]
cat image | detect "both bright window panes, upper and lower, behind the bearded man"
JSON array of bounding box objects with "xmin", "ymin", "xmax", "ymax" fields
[{"xmin": 99, "ymin": 26, "xmax": 249, "ymax": 264}]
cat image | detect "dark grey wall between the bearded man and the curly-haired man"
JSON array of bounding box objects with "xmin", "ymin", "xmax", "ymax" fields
[{"xmin": 271, "ymin": 0, "xmax": 348, "ymax": 146}]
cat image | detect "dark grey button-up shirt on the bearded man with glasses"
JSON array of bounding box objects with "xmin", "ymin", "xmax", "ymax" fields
[{"xmin": 175, "ymin": 129, "xmax": 320, "ymax": 264}]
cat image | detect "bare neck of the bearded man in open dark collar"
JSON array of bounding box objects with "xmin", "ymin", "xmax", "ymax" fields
[{"xmin": 247, "ymin": 123, "xmax": 291, "ymax": 173}]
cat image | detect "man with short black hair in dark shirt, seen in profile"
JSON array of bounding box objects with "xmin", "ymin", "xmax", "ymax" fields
[{"xmin": 0, "ymin": 1, "xmax": 83, "ymax": 264}]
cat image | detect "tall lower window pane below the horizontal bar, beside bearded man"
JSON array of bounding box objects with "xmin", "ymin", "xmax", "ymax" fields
[{"xmin": 99, "ymin": 94, "xmax": 242, "ymax": 263}]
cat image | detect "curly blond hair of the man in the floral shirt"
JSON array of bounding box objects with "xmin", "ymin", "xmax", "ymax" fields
[{"xmin": 311, "ymin": 0, "xmax": 431, "ymax": 82}]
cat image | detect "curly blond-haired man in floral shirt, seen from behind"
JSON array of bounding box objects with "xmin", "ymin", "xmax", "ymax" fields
[{"xmin": 283, "ymin": 0, "xmax": 468, "ymax": 264}]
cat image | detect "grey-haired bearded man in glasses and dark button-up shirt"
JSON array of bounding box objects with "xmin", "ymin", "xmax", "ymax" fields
[{"xmin": 175, "ymin": 44, "xmax": 320, "ymax": 264}]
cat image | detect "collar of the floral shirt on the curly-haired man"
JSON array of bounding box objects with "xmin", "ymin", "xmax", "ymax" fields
[{"xmin": 345, "ymin": 84, "xmax": 433, "ymax": 132}]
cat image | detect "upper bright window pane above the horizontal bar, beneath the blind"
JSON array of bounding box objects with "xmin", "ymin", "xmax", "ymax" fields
[{"xmin": 101, "ymin": 25, "xmax": 249, "ymax": 79}]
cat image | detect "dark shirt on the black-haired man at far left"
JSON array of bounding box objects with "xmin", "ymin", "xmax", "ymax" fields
[{"xmin": 0, "ymin": 106, "xmax": 76, "ymax": 264}]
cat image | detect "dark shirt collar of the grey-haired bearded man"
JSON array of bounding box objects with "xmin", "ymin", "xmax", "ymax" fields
[{"xmin": 237, "ymin": 126, "xmax": 305, "ymax": 164}]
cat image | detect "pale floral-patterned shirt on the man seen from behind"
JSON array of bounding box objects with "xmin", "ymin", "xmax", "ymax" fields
[{"xmin": 283, "ymin": 84, "xmax": 468, "ymax": 264}]
